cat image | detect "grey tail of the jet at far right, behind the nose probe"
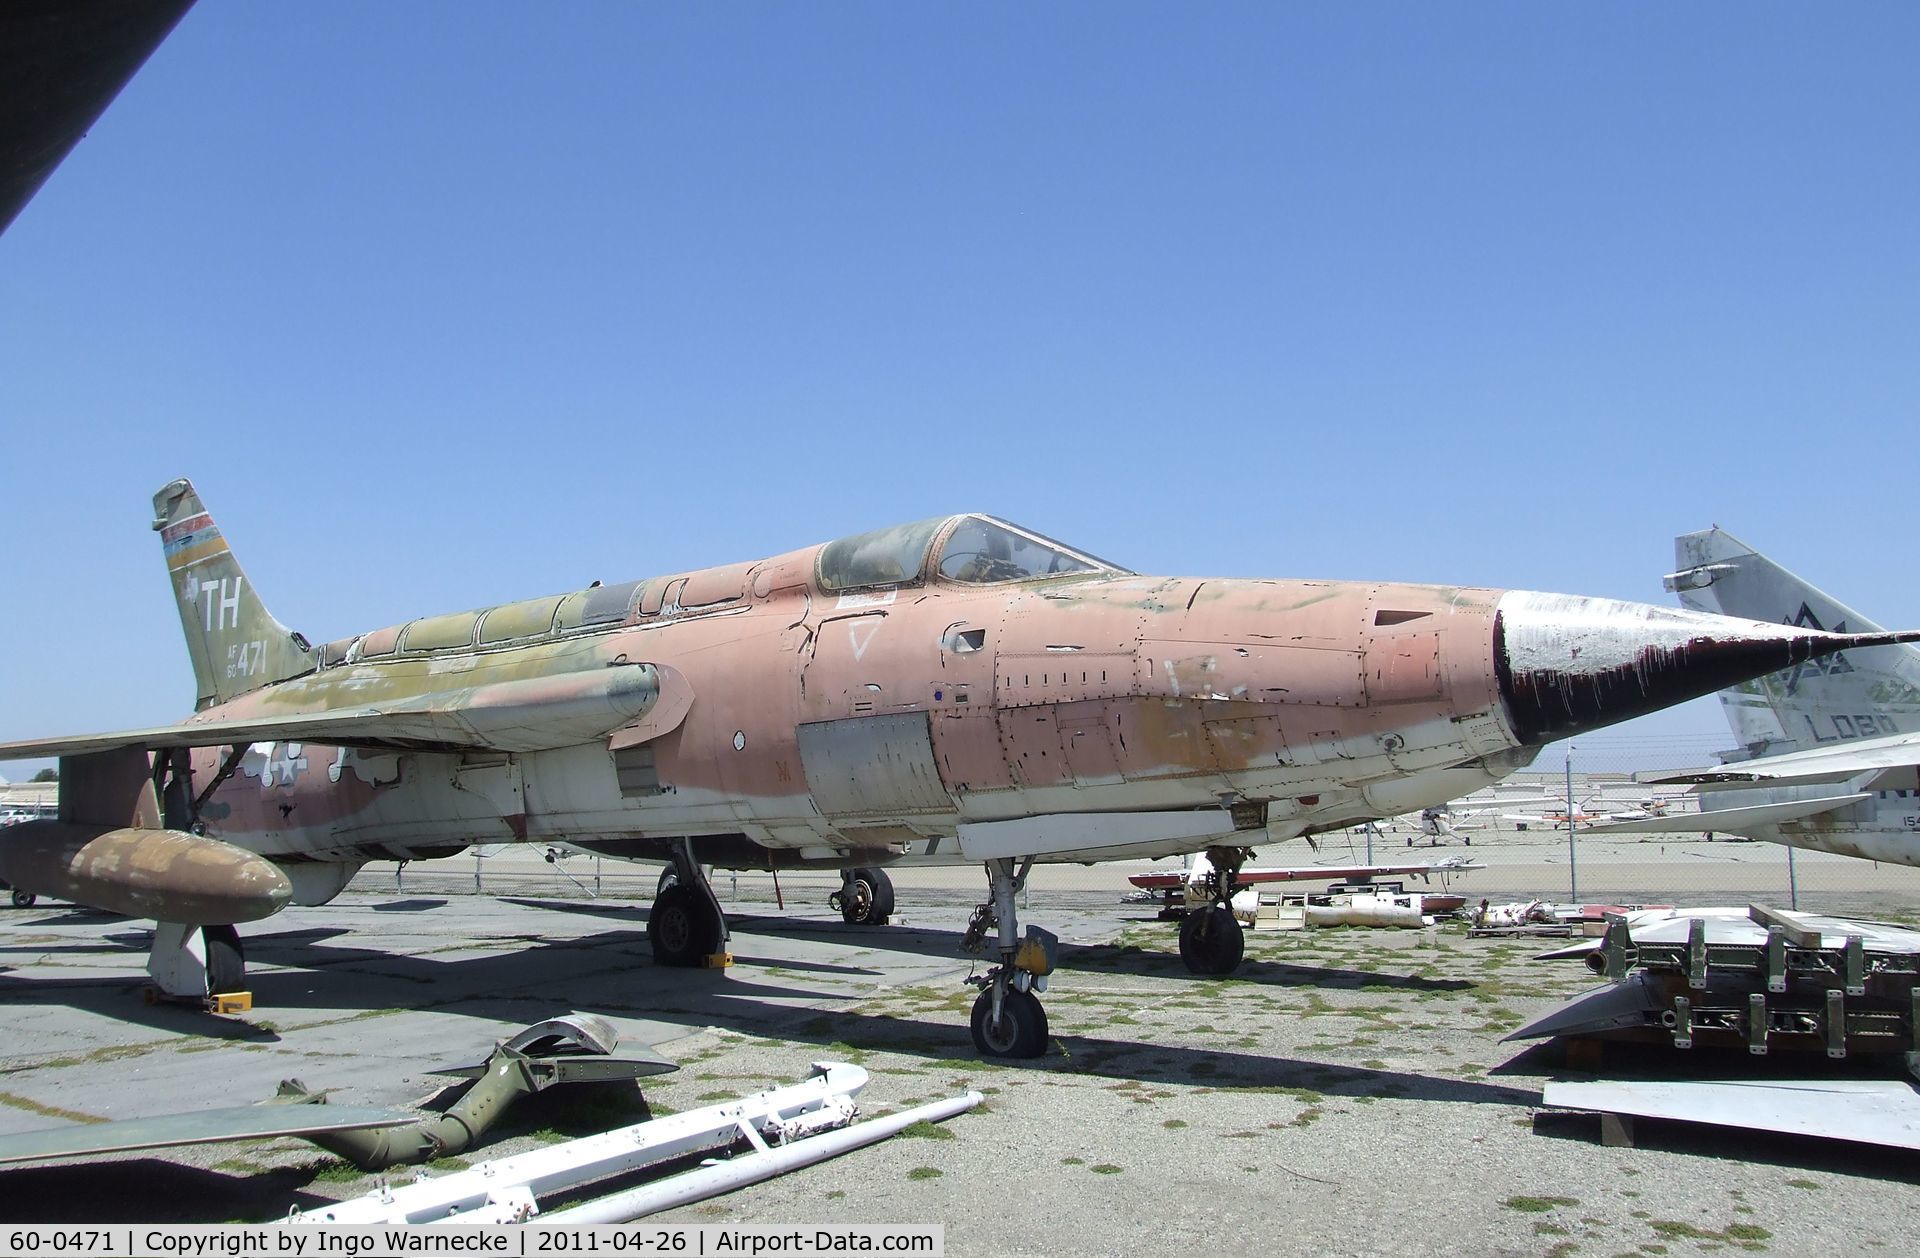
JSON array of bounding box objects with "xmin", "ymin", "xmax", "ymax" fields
[{"xmin": 1667, "ymin": 528, "xmax": 1920, "ymax": 755}]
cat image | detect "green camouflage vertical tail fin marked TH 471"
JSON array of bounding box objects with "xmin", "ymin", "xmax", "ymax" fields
[{"xmin": 154, "ymin": 480, "xmax": 315, "ymax": 709}]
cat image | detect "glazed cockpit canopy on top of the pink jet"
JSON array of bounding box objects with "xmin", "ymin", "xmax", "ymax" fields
[{"xmin": 818, "ymin": 515, "xmax": 1127, "ymax": 592}]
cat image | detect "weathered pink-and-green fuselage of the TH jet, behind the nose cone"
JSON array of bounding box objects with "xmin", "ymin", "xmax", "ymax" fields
[{"xmin": 180, "ymin": 568, "xmax": 1515, "ymax": 859}]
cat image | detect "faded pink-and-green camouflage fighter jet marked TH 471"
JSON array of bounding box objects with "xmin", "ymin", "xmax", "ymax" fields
[{"xmin": 0, "ymin": 480, "xmax": 1920, "ymax": 1056}]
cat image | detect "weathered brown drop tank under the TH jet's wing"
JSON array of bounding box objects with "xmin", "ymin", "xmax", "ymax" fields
[{"xmin": 0, "ymin": 822, "xmax": 292, "ymax": 926}]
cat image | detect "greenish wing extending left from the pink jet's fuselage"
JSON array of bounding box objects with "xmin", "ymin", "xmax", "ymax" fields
[{"xmin": 0, "ymin": 665, "xmax": 693, "ymax": 761}]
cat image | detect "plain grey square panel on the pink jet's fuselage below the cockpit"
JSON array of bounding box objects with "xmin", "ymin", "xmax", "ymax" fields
[{"xmin": 797, "ymin": 713, "xmax": 952, "ymax": 816}]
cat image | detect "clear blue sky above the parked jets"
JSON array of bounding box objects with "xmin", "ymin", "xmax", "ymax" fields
[{"xmin": 0, "ymin": 0, "xmax": 1920, "ymax": 776}]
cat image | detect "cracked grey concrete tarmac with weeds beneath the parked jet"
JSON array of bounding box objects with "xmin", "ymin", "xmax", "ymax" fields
[{"xmin": 0, "ymin": 845, "xmax": 1920, "ymax": 1254}]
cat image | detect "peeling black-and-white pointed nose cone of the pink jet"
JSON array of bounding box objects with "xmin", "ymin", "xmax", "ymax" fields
[{"xmin": 1494, "ymin": 590, "xmax": 1920, "ymax": 747}]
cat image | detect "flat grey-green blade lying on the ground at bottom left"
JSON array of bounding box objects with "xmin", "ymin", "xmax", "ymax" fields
[{"xmin": 0, "ymin": 1104, "xmax": 417, "ymax": 1164}]
